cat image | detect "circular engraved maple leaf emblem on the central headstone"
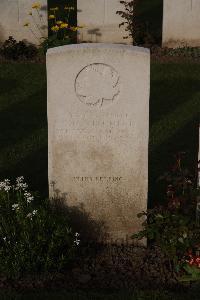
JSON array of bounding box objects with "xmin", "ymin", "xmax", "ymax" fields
[{"xmin": 75, "ymin": 63, "xmax": 120, "ymax": 107}]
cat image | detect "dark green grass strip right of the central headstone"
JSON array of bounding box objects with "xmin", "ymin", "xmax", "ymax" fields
[{"xmin": 149, "ymin": 64, "xmax": 200, "ymax": 207}]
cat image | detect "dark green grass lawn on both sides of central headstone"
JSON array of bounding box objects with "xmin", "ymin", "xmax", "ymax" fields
[{"xmin": 0, "ymin": 62, "xmax": 200, "ymax": 206}]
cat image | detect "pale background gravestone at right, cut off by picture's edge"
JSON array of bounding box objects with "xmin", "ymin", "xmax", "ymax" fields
[{"xmin": 163, "ymin": 0, "xmax": 200, "ymax": 48}]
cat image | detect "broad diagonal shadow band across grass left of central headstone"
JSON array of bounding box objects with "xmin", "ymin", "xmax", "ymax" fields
[{"xmin": 0, "ymin": 90, "xmax": 47, "ymax": 151}]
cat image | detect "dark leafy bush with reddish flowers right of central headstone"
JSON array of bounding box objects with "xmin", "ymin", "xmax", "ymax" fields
[{"xmin": 133, "ymin": 152, "xmax": 200, "ymax": 280}]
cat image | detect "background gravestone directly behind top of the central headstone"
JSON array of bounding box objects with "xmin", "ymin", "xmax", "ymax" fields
[{"xmin": 77, "ymin": 0, "xmax": 132, "ymax": 44}]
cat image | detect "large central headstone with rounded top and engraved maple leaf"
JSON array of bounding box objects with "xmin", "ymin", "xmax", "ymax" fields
[{"xmin": 47, "ymin": 44, "xmax": 150, "ymax": 242}]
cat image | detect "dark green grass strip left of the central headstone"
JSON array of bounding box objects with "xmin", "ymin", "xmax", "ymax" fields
[{"xmin": 0, "ymin": 64, "xmax": 47, "ymax": 194}]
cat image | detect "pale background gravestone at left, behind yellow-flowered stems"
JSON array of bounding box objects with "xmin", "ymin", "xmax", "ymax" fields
[{"xmin": 0, "ymin": 0, "xmax": 48, "ymax": 44}]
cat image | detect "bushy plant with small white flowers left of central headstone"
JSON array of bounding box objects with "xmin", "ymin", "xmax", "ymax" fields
[{"xmin": 0, "ymin": 177, "xmax": 79, "ymax": 278}]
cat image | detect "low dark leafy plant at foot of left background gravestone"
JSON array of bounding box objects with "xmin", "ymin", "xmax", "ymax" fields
[{"xmin": 0, "ymin": 36, "xmax": 38, "ymax": 60}]
